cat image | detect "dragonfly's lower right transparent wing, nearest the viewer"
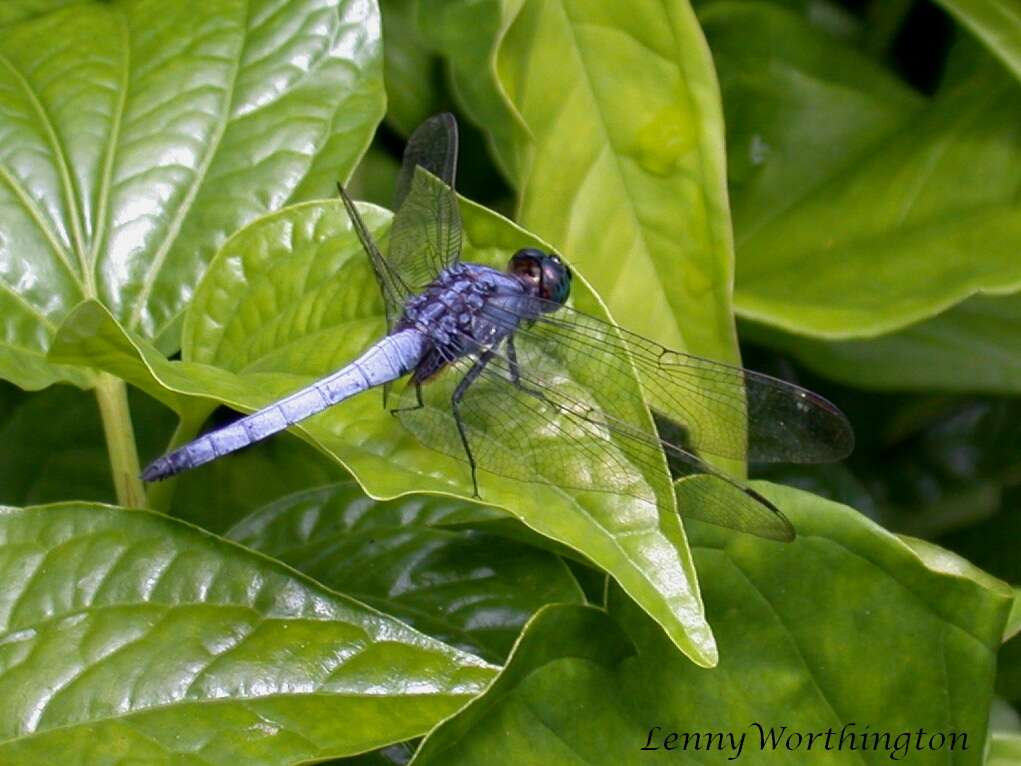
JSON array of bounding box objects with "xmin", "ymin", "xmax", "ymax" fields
[{"xmin": 397, "ymin": 330, "xmax": 793, "ymax": 540}]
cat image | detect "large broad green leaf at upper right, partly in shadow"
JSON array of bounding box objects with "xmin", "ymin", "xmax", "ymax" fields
[{"xmin": 707, "ymin": 3, "xmax": 1021, "ymax": 339}]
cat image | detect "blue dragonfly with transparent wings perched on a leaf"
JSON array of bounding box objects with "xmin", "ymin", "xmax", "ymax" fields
[{"xmin": 143, "ymin": 113, "xmax": 854, "ymax": 540}]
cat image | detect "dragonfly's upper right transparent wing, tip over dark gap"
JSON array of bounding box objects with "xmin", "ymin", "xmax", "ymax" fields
[{"xmin": 494, "ymin": 304, "xmax": 855, "ymax": 463}]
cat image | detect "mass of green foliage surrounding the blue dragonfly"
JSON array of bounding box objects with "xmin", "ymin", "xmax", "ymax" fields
[{"xmin": 0, "ymin": 0, "xmax": 1021, "ymax": 764}]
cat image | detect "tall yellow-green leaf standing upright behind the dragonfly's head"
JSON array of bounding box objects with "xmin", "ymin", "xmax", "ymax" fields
[{"xmin": 497, "ymin": 0, "xmax": 737, "ymax": 362}]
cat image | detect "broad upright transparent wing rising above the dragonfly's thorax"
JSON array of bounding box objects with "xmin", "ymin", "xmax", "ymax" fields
[{"xmin": 387, "ymin": 114, "xmax": 461, "ymax": 300}]
